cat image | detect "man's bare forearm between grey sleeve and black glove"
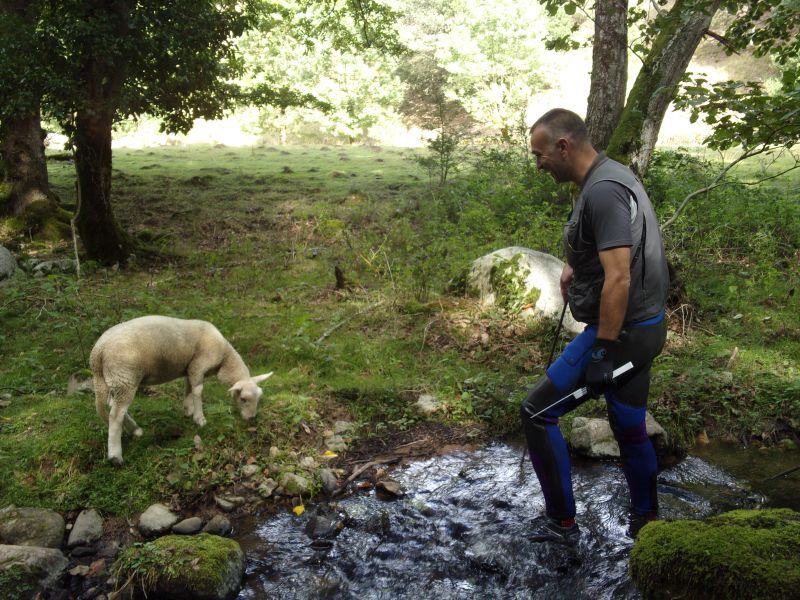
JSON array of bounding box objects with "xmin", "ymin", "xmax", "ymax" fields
[{"xmin": 597, "ymin": 246, "xmax": 631, "ymax": 340}]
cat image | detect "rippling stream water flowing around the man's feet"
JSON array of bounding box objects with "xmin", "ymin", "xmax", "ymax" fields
[{"xmin": 233, "ymin": 443, "xmax": 792, "ymax": 600}]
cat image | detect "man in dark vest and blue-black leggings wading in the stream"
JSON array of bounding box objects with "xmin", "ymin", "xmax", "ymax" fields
[{"xmin": 521, "ymin": 109, "xmax": 669, "ymax": 544}]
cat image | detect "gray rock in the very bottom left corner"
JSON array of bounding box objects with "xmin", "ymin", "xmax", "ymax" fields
[{"xmin": 0, "ymin": 545, "xmax": 69, "ymax": 598}]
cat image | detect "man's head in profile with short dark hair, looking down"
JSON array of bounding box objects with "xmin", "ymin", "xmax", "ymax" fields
[{"xmin": 530, "ymin": 108, "xmax": 597, "ymax": 185}]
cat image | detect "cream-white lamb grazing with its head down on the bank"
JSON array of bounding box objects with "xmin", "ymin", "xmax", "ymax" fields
[{"xmin": 89, "ymin": 315, "xmax": 272, "ymax": 466}]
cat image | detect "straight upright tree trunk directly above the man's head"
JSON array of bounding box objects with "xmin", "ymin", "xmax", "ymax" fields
[{"xmin": 586, "ymin": 0, "xmax": 628, "ymax": 150}]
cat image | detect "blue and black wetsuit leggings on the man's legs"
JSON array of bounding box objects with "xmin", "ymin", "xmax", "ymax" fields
[{"xmin": 520, "ymin": 313, "xmax": 666, "ymax": 520}]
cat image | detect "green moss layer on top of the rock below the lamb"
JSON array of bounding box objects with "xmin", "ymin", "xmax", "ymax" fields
[{"xmin": 114, "ymin": 533, "xmax": 243, "ymax": 595}]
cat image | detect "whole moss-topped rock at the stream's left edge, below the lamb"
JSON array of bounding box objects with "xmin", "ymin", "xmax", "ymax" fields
[{"xmin": 115, "ymin": 533, "xmax": 245, "ymax": 600}]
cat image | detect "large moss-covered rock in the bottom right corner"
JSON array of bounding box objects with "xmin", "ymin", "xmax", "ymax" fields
[{"xmin": 630, "ymin": 509, "xmax": 800, "ymax": 600}]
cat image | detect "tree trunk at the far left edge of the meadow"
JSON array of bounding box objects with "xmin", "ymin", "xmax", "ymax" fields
[{"xmin": 0, "ymin": 109, "xmax": 52, "ymax": 215}]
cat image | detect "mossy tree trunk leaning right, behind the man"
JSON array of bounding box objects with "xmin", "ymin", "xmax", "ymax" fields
[{"xmin": 607, "ymin": 0, "xmax": 720, "ymax": 177}]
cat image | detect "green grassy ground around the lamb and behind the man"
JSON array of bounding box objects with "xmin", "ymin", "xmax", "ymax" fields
[{"xmin": 0, "ymin": 146, "xmax": 800, "ymax": 516}]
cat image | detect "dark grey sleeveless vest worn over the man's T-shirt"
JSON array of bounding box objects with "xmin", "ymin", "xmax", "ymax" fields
[{"xmin": 564, "ymin": 154, "xmax": 669, "ymax": 325}]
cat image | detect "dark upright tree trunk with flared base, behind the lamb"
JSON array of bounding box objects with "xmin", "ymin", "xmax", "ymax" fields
[{"xmin": 75, "ymin": 107, "xmax": 131, "ymax": 265}]
